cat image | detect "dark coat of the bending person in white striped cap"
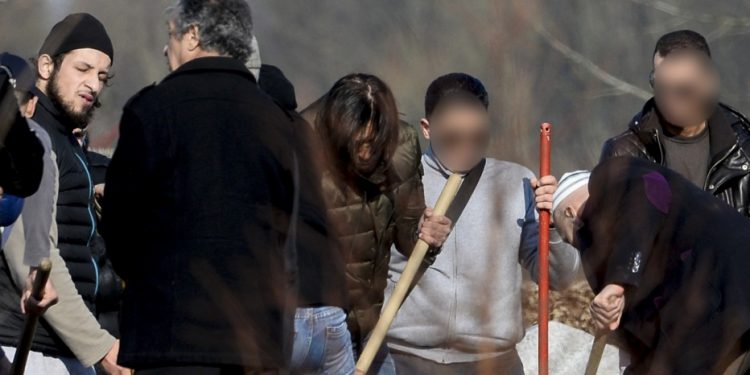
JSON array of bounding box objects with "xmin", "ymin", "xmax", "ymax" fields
[{"xmin": 577, "ymin": 157, "xmax": 750, "ymax": 374}]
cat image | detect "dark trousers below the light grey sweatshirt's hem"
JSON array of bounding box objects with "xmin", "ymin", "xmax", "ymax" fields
[{"xmin": 391, "ymin": 350, "xmax": 524, "ymax": 375}]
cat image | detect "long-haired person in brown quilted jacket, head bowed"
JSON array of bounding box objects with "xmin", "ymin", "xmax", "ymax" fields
[{"xmin": 302, "ymin": 74, "xmax": 450, "ymax": 374}]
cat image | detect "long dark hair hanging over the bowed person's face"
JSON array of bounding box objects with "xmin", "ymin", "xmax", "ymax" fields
[{"xmin": 316, "ymin": 73, "xmax": 399, "ymax": 177}]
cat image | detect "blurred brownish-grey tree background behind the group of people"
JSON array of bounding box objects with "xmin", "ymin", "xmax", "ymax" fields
[{"xmin": 0, "ymin": 0, "xmax": 750, "ymax": 172}]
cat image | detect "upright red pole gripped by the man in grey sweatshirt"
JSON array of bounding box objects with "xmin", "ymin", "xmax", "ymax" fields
[{"xmin": 539, "ymin": 123, "xmax": 552, "ymax": 375}]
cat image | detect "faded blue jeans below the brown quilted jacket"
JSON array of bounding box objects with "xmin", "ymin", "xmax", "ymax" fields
[{"xmin": 290, "ymin": 306, "xmax": 354, "ymax": 375}]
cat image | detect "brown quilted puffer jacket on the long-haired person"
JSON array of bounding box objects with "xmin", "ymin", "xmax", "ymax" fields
[{"xmin": 301, "ymin": 102, "xmax": 433, "ymax": 344}]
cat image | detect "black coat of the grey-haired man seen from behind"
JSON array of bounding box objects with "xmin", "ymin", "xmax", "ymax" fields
[{"xmin": 102, "ymin": 57, "xmax": 301, "ymax": 369}]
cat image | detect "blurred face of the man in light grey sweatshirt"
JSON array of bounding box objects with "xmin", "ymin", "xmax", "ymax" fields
[{"xmin": 422, "ymin": 97, "xmax": 490, "ymax": 173}]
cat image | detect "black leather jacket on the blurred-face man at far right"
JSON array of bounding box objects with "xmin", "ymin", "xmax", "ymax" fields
[{"xmin": 600, "ymin": 99, "xmax": 750, "ymax": 218}]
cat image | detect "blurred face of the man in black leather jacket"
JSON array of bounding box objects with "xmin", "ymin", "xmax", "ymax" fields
[{"xmin": 654, "ymin": 51, "xmax": 719, "ymax": 128}]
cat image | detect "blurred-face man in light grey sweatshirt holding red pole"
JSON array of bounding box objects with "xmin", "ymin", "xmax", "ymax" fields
[{"xmin": 386, "ymin": 73, "xmax": 580, "ymax": 375}]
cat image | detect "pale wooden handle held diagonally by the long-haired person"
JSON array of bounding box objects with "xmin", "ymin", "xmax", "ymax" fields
[{"xmin": 357, "ymin": 174, "xmax": 463, "ymax": 374}]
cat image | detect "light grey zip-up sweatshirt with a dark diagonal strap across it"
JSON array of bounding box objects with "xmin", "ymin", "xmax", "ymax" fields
[{"xmin": 386, "ymin": 149, "xmax": 580, "ymax": 363}]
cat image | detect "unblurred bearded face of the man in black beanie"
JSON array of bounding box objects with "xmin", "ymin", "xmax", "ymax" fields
[{"xmin": 38, "ymin": 48, "xmax": 112, "ymax": 127}]
